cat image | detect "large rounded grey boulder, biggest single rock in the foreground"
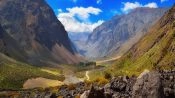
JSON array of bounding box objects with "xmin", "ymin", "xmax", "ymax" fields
[{"xmin": 132, "ymin": 72, "xmax": 162, "ymax": 98}]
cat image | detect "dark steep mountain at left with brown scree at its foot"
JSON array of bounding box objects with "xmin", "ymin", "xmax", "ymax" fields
[{"xmin": 0, "ymin": 0, "xmax": 80, "ymax": 65}]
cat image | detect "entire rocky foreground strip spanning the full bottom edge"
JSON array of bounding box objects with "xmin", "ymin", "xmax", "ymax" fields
[{"xmin": 0, "ymin": 71, "xmax": 175, "ymax": 98}]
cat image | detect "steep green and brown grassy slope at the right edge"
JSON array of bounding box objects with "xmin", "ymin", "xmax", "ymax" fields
[{"xmin": 110, "ymin": 5, "xmax": 175, "ymax": 74}]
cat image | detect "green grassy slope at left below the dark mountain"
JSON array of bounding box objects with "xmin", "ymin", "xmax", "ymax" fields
[{"xmin": 0, "ymin": 54, "xmax": 61, "ymax": 89}]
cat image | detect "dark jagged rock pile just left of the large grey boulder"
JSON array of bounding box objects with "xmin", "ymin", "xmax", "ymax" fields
[{"xmin": 81, "ymin": 76, "xmax": 136, "ymax": 98}]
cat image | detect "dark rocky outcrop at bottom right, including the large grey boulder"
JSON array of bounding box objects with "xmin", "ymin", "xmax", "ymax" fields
[{"xmin": 82, "ymin": 71, "xmax": 175, "ymax": 98}]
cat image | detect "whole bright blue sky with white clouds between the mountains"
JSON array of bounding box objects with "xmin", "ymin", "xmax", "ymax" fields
[{"xmin": 46, "ymin": 0, "xmax": 175, "ymax": 33}]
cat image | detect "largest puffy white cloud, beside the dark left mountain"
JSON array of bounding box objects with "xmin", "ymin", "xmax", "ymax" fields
[{"xmin": 57, "ymin": 7, "xmax": 103, "ymax": 33}]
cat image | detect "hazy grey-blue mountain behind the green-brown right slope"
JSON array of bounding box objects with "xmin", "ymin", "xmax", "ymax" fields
[{"xmin": 84, "ymin": 8, "xmax": 167, "ymax": 58}]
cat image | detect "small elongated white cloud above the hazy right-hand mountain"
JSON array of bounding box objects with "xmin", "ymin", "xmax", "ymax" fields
[{"xmin": 122, "ymin": 2, "xmax": 158, "ymax": 12}]
